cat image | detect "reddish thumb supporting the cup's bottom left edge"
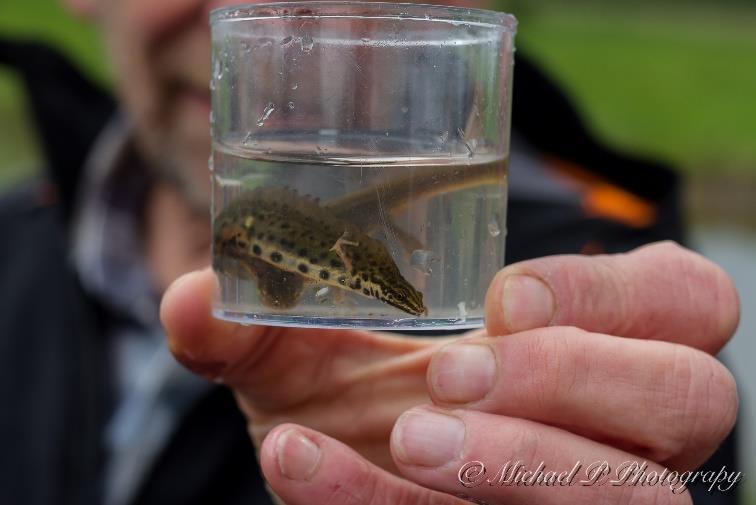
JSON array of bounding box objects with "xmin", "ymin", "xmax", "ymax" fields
[{"xmin": 160, "ymin": 269, "xmax": 429, "ymax": 410}]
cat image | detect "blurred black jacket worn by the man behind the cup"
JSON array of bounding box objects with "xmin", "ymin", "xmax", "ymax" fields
[{"xmin": 0, "ymin": 42, "xmax": 736, "ymax": 505}]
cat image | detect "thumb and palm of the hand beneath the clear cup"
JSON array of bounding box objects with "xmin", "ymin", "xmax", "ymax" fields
[{"xmin": 162, "ymin": 270, "xmax": 466, "ymax": 472}]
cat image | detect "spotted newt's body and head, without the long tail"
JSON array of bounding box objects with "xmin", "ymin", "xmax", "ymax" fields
[{"xmin": 213, "ymin": 187, "xmax": 428, "ymax": 316}]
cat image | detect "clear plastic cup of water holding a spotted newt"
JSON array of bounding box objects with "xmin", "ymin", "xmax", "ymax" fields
[{"xmin": 210, "ymin": 2, "xmax": 516, "ymax": 329}]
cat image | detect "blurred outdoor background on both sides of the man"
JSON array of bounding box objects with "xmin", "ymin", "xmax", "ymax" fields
[{"xmin": 0, "ymin": 0, "xmax": 756, "ymax": 505}]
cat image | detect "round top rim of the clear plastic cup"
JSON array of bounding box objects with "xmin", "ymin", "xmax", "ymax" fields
[{"xmin": 210, "ymin": 0, "xmax": 517, "ymax": 34}]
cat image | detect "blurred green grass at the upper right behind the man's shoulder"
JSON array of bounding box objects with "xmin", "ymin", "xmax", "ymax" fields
[{"xmin": 515, "ymin": 1, "xmax": 756, "ymax": 175}]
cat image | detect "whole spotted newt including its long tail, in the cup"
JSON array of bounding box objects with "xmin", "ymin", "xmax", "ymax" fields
[{"xmin": 213, "ymin": 159, "xmax": 506, "ymax": 316}]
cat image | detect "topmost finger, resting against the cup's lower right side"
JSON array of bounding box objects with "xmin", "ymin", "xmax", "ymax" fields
[{"xmin": 486, "ymin": 242, "xmax": 740, "ymax": 354}]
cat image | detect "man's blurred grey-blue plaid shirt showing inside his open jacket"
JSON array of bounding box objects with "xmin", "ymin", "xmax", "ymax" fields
[{"xmin": 72, "ymin": 117, "xmax": 209, "ymax": 505}]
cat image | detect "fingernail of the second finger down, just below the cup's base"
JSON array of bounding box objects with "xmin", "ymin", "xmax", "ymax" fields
[{"xmin": 430, "ymin": 344, "xmax": 496, "ymax": 403}]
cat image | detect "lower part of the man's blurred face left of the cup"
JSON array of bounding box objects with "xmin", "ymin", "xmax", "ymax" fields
[{"xmin": 78, "ymin": 0, "xmax": 482, "ymax": 208}]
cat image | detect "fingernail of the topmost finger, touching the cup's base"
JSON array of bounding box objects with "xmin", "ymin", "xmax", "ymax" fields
[{"xmin": 502, "ymin": 274, "xmax": 556, "ymax": 332}]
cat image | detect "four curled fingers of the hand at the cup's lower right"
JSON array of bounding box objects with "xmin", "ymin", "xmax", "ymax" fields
[{"xmin": 164, "ymin": 244, "xmax": 738, "ymax": 505}]
